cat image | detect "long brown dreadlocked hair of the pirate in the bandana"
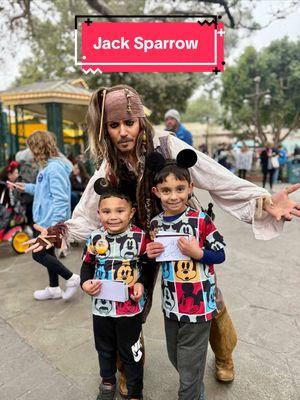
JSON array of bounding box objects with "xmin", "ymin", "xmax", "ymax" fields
[{"xmin": 87, "ymin": 85, "xmax": 158, "ymax": 231}]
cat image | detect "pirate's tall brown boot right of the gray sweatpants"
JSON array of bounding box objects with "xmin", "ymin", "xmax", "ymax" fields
[{"xmin": 209, "ymin": 307, "xmax": 237, "ymax": 382}]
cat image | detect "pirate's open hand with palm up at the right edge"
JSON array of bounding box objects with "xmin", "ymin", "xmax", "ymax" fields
[{"xmin": 264, "ymin": 183, "xmax": 300, "ymax": 221}]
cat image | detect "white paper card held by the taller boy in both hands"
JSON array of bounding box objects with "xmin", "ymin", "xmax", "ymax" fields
[{"xmin": 154, "ymin": 232, "xmax": 190, "ymax": 262}]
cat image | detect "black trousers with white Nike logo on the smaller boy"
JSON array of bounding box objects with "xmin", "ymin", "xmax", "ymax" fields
[{"xmin": 93, "ymin": 314, "xmax": 144, "ymax": 399}]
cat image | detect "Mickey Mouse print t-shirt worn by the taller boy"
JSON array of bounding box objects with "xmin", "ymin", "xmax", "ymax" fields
[{"xmin": 151, "ymin": 207, "xmax": 225, "ymax": 322}]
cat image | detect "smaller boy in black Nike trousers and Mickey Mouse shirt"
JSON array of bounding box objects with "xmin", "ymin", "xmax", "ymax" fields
[{"xmin": 81, "ymin": 179, "xmax": 146, "ymax": 400}]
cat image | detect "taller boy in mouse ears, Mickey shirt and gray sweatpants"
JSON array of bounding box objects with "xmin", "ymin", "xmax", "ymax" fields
[{"xmin": 147, "ymin": 150, "xmax": 225, "ymax": 400}]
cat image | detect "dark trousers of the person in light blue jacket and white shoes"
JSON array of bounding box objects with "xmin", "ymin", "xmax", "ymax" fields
[{"xmin": 32, "ymin": 231, "xmax": 73, "ymax": 287}]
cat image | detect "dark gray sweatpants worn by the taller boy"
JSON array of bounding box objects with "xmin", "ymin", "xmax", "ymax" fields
[{"xmin": 164, "ymin": 317, "xmax": 211, "ymax": 400}]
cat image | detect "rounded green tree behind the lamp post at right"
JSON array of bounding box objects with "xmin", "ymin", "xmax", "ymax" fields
[{"xmin": 221, "ymin": 38, "xmax": 300, "ymax": 144}]
